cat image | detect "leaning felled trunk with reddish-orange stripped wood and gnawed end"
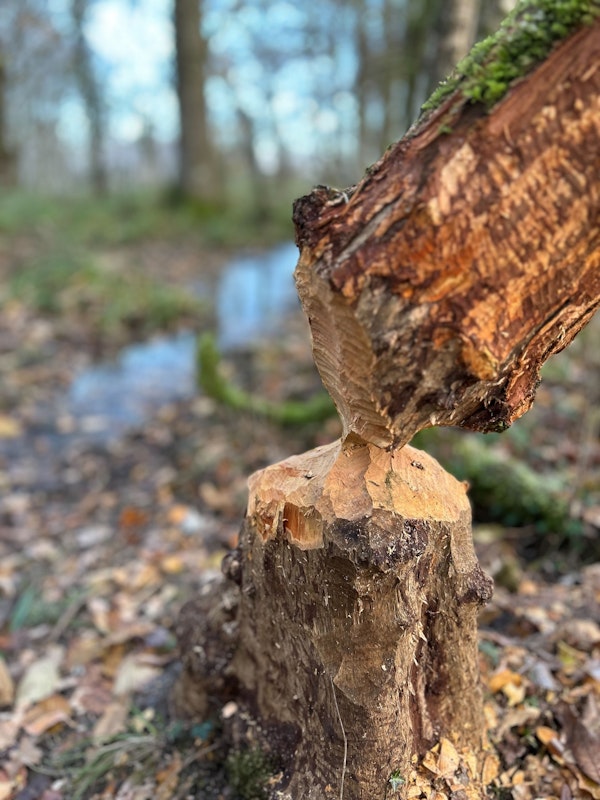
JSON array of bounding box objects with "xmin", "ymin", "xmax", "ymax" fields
[{"xmin": 295, "ymin": 22, "xmax": 600, "ymax": 446}]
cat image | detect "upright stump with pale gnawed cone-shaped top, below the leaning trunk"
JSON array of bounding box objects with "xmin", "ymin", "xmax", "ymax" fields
[{"xmin": 233, "ymin": 442, "xmax": 491, "ymax": 800}]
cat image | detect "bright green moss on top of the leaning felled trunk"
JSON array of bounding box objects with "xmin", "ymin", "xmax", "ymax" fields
[{"xmin": 423, "ymin": 0, "xmax": 600, "ymax": 111}]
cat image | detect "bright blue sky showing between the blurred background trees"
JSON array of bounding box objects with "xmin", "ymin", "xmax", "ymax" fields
[{"xmin": 54, "ymin": 0, "xmax": 356, "ymax": 170}]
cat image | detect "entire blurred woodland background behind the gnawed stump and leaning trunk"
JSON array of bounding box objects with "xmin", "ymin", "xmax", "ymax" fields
[{"xmin": 0, "ymin": 0, "xmax": 600, "ymax": 800}]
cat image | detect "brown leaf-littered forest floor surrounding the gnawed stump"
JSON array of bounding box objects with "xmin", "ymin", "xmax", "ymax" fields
[{"xmin": 0, "ymin": 195, "xmax": 600, "ymax": 800}]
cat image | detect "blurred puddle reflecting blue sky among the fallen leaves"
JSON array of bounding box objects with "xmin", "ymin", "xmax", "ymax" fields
[{"xmin": 65, "ymin": 242, "xmax": 298, "ymax": 438}]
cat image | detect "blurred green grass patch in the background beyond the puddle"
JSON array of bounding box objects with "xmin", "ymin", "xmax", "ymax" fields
[{"xmin": 0, "ymin": 191, "xmax": 292, "ymax": 341}]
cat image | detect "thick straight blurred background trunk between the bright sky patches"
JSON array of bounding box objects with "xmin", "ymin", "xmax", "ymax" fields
[{"xmin": 174, "ymin": 0, "xmax": 220, "ymax": 200}]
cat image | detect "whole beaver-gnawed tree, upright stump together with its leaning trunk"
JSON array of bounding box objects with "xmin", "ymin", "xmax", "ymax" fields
[{"xmin": 179, "ymin": 7, "xmax": 600, "ymax": 800}]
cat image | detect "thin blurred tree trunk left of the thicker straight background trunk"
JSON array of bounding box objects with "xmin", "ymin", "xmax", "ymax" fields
[{"xmin": 71, "ymin": 0, "xmax": 108, "ymax": 195}]
